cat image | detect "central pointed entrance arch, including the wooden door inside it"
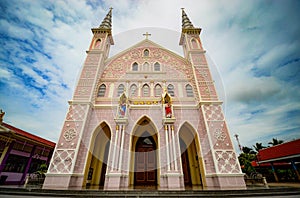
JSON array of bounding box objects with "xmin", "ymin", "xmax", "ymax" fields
[{"xmin": 129, "ymin": 116, "xmax": 159, "ymax": 189}]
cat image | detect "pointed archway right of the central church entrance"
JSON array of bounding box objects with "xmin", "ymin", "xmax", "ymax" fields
[{"xmin": 179, "ymin": 123, "xmax": 204, "ymax": 189}]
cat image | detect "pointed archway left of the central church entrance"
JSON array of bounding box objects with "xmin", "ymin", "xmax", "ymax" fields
[{"xmin": 85, "ymin": 123, "xmax": 111, "ymax": 188}]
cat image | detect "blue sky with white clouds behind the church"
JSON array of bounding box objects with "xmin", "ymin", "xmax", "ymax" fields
[{"xmin": 0, "ymin": 0, "xmax": 300, "ymax": 152}]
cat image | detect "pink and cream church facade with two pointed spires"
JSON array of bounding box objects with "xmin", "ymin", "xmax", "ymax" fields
[{"xmin": 43, "ymin": 10, "xmax": 245, "ymax": 190}]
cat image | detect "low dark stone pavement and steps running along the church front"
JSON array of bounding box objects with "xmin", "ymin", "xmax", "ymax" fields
[{"xmin": 0, "ymin": 183, "xmax": 300, "ymax": 198}]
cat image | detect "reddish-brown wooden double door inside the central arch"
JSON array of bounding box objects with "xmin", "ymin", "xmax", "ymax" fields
[{"xmin": 134, "ymin": 137, "xmax": 157, "ymax": 186}]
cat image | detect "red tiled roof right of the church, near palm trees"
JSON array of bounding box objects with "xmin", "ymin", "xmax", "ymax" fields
[{"xmin": 257, "ymin": 139, "xmax": 300, "ymax": 161}]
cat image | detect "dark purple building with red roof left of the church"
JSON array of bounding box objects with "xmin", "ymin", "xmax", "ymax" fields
[{"xmin": 0, "ymin": 111, "xmax": 55, "ymax": 185}]
